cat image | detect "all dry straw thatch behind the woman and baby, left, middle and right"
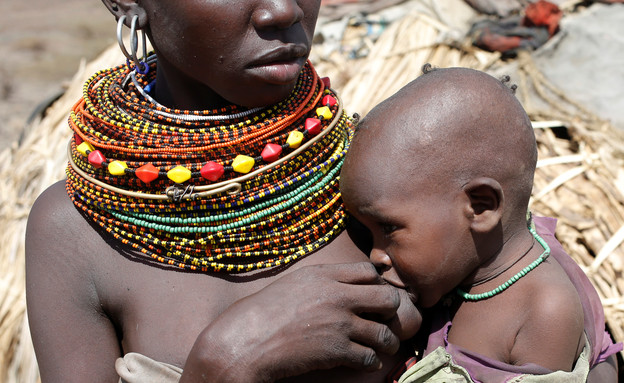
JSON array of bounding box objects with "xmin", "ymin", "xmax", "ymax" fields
[{"xmin": 0, "ymin": 3, "xmax": 624, "ymax": 383}]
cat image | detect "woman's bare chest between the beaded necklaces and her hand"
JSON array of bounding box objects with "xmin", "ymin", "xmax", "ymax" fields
[{"xmin": 95, "ymin": 231, "xmax": 366, "ymax": 367}]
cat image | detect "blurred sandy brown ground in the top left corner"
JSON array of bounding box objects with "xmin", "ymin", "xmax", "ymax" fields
[{"xmin": 0, "ymin": 0, "xmax": 115, "ymax": 151}]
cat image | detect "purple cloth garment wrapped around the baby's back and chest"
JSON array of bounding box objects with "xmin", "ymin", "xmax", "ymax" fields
[{"xmin": 424, "ymin": 217, "xmax": 622, "ymax": 382}]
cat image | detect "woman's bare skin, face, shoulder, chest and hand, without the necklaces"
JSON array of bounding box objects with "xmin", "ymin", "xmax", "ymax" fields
[{"xmin": 26, "ymin": 0, "xmax": 420, "ymax": 382}]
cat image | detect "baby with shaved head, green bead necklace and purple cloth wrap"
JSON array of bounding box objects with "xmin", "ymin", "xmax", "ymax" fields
[{"xmin": 340, "ymin": 66, "xmax": 621, "ymax": 382}]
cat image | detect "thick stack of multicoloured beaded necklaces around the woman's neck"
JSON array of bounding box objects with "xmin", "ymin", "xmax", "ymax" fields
[{"xmin": 66, "ymin": 58, "xmax": 353, "ymax": 273}]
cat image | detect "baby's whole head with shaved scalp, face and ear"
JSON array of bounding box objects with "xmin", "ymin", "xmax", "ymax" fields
[{"xmin": 340, "ymin": 68, "xmax": 537, "ymax": 307}]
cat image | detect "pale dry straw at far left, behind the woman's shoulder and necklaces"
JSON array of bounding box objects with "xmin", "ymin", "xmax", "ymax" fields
[{"xmin": 0, "ymin": 46, "xmax": 124, "ymax": 383}]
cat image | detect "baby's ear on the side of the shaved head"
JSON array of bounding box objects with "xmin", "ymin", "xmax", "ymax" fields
[{"xmin": 463, "ymin": 177, "xmax": 504, "ymax": 233}]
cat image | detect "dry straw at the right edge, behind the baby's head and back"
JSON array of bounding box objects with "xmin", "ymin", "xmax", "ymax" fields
[{"xmin": 518, "ymin": 54, "xmax": 624, "ymax": 354}]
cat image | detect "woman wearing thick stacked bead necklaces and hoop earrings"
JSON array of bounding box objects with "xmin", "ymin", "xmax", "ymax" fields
[{"xmin": 26, "ymin": 0, "xmax": 419, "ymax": 382}]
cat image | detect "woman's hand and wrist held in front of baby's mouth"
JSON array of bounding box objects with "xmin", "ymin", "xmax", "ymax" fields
[{"xmin": 180, "ymin": 263, "xmax": 421, "ymax": 383}]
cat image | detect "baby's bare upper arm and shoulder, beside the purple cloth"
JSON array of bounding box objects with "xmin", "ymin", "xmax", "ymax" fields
[{"xmin": 510, "ymin": 282, "xmax": 585, "ymax": 371}]
